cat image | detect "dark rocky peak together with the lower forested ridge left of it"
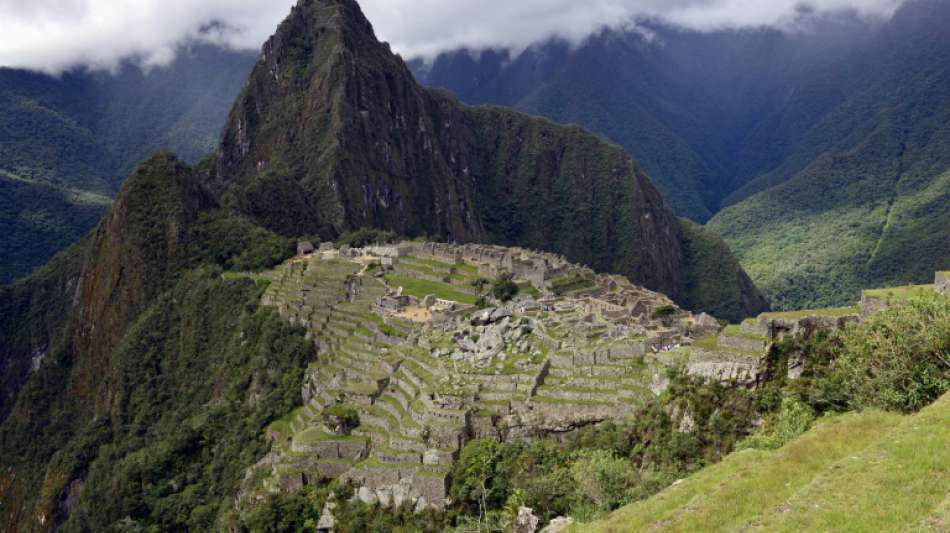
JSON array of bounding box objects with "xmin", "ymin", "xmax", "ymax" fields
[{"xmin": 0, "ymin": 0, "xmax": 764, "ymax": 531}]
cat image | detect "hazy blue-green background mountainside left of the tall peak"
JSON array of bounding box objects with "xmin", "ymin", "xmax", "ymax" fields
[{"xmin": 0, "ymin": 46, "xmax": 254, "ymax": 282}]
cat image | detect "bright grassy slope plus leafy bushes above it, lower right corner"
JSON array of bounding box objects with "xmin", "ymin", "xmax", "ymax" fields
[{"xmin": 578, "ymin": 297, "xmax": 950, "ymax": 531}]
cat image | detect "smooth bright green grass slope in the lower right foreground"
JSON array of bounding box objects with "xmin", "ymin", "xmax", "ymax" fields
[{"xmin": 576, "ymin": 395, "xmax": 950, "ymax": 532}]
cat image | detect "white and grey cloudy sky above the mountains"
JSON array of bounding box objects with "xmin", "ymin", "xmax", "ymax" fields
[{"xmin": 0, "ymin": 0, "xmax": 904, "ymax": 73}]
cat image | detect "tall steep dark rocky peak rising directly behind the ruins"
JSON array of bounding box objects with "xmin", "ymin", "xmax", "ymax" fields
[{"xmin": 210, "ymin": 1, "xmax": 765, "ymax": 318}]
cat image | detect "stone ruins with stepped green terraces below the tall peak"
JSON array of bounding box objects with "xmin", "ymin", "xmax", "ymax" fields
[{"xmin": 232, "ymin": 243, "xmax": 765, "ymax": 508}]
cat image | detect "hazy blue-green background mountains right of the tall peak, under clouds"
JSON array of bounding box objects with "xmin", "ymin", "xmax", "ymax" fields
[{"xmin": 412, "ymin": 0, "xmax": 950, "ymax": 308}]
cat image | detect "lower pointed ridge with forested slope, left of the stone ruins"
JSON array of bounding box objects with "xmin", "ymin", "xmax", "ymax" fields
[{"xmin": 0, "ymin": 154, "xmax": 302, "ymax": 531}]
